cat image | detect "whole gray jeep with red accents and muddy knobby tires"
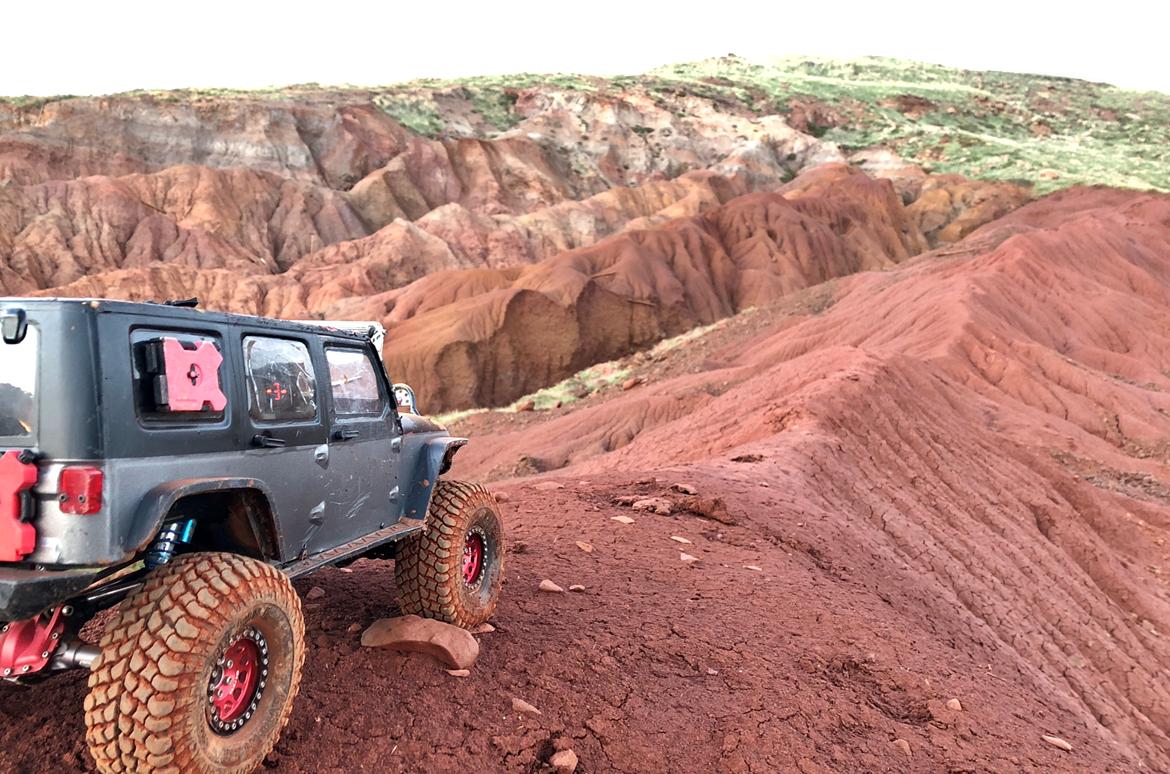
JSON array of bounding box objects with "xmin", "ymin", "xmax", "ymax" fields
[{"xmin": 0, "ymin": 298, "xmax": 504, "ymax": 773}]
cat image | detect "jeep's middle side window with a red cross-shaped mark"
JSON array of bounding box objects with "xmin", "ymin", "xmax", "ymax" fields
[{"xmin": 243, "ymin": 336, "xmax": 317, "ymax": 422}]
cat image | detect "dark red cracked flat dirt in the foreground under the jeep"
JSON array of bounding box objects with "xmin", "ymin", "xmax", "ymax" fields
[{"xmin": 0, "ymin": 479, "xmax": 1128, "ymax": 773}]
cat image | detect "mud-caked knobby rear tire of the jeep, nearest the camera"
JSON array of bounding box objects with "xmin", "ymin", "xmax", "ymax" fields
[{"xmin": 85, "ymin": 553, "xmax": 304, "ymax": 774}]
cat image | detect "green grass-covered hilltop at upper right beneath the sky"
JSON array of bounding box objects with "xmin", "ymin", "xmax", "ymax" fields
[{"xmin": 378, "ymin": 57, "xmax": 1170, "ymax": 192}]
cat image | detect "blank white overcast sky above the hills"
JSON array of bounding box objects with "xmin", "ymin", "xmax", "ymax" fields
[{"xmin": 0, "ymin": 0, "xmax": 1170, "ymax": 96}]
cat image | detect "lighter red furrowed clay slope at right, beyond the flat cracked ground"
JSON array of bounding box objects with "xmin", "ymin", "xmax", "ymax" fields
[{"xmin": 446, "ymin": 191, "xmax": 1170, "ymax": 770}]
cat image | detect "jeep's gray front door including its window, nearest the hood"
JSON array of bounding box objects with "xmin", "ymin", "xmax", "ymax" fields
[{"xmin": 323, "ymin": 338, "xmax": 402, "ymax": 551}]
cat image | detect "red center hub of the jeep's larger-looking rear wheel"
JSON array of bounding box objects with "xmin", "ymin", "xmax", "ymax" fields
[{"xmin": 207, "ymin": 627, "xmax": 268, "ymax": 734}]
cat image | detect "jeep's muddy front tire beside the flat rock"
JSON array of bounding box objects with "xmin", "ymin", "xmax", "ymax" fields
[{"xmin": 394, "ymin": 481, "xmax": 504, "ymax": 629}]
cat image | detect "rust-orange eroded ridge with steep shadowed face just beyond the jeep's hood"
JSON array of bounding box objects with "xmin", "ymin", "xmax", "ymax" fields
[{"xmin": 379, "ymin": 167, "xmax": 924, "ymax": 410}]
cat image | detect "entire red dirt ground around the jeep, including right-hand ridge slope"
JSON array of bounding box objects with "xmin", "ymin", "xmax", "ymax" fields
[{"xmin": 0, "ymin": 189, "xmax": 1170, "ymax": 772}]
